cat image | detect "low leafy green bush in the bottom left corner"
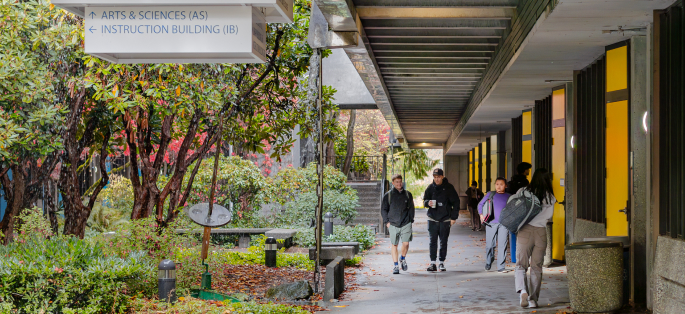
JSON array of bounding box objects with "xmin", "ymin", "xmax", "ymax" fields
[{"xmin": 0, "ymin": 237, "xmax": 155, "ymax": 313}]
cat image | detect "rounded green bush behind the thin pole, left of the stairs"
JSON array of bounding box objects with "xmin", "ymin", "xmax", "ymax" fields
[{"xmin": 270, "ymin": 163, "xmax": 359, "ymax": 227}]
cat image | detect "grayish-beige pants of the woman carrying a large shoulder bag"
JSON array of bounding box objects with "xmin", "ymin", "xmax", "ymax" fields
[{"xmin": 515, "ymin": 225, "xmax": 547, "ymax": 302}]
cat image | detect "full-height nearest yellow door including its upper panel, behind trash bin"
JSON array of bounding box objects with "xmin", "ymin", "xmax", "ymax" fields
[{"xmin": 605, "ymin": 45, "xmax": 630, "ymax": 236}]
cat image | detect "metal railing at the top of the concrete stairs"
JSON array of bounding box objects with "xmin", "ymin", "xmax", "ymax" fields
[{"xmin": 326, "ymin": 155, "xmax": 387, "ymax": 181}]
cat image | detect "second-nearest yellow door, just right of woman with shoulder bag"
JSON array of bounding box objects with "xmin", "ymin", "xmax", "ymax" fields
[{"xmin": 551, "ymin": 89, "xmax": 566, "ymax": 261}]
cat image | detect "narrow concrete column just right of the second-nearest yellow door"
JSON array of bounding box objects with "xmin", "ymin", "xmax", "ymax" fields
[{"xmin": 564, "ymin": 83, "xmax": 576, "ymax": 244}]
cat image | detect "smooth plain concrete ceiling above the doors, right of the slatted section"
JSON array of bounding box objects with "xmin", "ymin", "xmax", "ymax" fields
[{"xmin": 446, "ymin": 0, "xmax": 674, "ymax": 155}]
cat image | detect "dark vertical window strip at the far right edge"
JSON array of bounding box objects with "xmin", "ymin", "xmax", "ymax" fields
[{"xmin": 655, "ymin": 1, "xmax": 685, "ymax": 239}]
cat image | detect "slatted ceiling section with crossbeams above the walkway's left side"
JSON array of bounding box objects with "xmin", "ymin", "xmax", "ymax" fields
[{"xmin": 353, "ymin": 0, "xmax": 518, "ymax": 147}]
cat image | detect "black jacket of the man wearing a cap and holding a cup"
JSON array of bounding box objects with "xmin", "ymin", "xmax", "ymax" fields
[{"xmin": 423, "ymin": 181, "xmax": 460, "ymax": 221}]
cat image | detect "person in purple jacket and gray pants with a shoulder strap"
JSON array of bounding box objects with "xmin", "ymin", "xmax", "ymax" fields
[{"xmin": 478, "ymin": 177, "xmax": 511, "ymax": 273}]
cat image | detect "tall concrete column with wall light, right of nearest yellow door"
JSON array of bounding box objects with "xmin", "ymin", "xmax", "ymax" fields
[{"xmin": 630, "ymin": 36, "xmax": 650, "ymax": 303}]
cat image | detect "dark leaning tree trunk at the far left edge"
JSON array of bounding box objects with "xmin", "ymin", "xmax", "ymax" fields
[{"xmin": 0, "ymin": 165, "xmax": 26, "ymax": 245}]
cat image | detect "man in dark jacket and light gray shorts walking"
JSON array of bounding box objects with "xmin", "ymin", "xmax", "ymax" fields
[{"xmin": 381, "ymin": 174, "xmax": 415, "ymax": 274}]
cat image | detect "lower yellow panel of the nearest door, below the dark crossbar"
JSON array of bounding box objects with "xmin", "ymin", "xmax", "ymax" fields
[{"xmin": 606, "ymin": 100, "xmax": 630, "ymax": 236}]
